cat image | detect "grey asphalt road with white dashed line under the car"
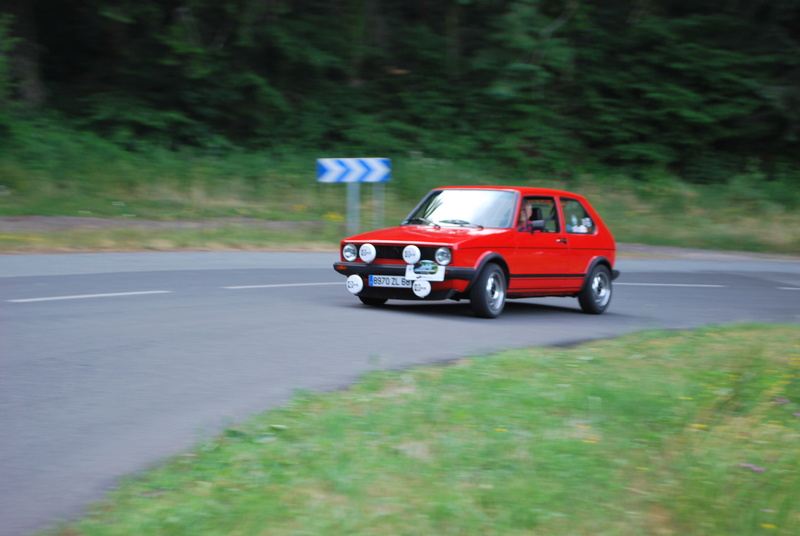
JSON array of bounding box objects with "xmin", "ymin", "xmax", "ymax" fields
[{"xmin": 0, "ymin": 249, "xmax": 800, "ymax": 536}]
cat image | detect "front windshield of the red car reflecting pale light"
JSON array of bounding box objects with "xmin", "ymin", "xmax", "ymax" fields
[{"xmin": 403, "ymin": 189, "xmax": 516, "ymax": 229}]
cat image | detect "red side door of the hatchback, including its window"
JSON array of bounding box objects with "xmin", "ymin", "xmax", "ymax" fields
[{"xmin": 508, "ymin": 196, "xmax": 581, "ymax": 295}]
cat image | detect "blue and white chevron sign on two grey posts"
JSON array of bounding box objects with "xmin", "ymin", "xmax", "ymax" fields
[{"xmin": 317, "ymin": 158, "xmax": 392, "ymax": 234}]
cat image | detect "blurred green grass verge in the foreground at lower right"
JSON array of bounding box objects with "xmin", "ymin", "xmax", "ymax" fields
[{"xmin": 51, "ymin": 325, "xmax": 800, "ymax": 536}]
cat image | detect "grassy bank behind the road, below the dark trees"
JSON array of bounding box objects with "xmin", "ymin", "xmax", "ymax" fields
[{"xmin": 0, "ymin": 136, "xmax": 800, "ymax": 254}]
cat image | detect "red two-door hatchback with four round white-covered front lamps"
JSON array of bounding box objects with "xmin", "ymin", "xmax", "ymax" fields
[{"xmin": 333, "ymin": 186, "xmax": 619, "ymax": 318}]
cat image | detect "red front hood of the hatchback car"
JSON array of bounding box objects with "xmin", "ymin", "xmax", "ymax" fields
[{"xmin": 344, "ymin": 225, "xmax": 511, "ymax": 247}]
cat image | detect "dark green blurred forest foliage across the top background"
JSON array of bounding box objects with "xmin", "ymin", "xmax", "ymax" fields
[{"xmin": 6, "ymin": 0, "xmax": 800, "ymax": 183}]
